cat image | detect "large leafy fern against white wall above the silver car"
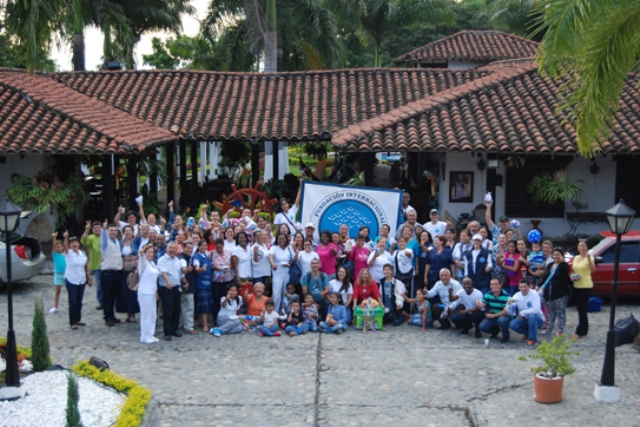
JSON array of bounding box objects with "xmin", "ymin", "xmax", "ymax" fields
[{"xmin": 7, "ymin": 172, "xmax": 89, "ymax": 229}]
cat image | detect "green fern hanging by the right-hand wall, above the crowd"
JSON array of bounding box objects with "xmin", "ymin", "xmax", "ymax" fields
[{"xmin": 527, "ymin": 169, "xmax": 585, "ymax": 205}]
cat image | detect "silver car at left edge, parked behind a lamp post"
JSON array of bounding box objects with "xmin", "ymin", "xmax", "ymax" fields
[{"xmin": 0, "ymin": 220, "xmax": 47, "ymax": 287}]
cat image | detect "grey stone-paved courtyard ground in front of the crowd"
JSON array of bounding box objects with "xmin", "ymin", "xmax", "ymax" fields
[{"xmin": 0, "ymin": 276, "xmax": 640, "ymax": 427}]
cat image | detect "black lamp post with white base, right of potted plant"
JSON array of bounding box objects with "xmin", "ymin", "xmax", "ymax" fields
[{"xmin": 594, "ymin": 199, "xmax": 636, "ymax": 402}]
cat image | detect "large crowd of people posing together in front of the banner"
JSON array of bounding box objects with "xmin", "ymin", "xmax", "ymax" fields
[{"xmin": 50, "ymin": 186, "xmax": 595, "ymax": 348}]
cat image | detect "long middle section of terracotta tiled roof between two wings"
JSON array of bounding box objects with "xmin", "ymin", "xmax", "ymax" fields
[{"xmin": 53, "ymin": 68, "xmax": 486, "ymax": 140}]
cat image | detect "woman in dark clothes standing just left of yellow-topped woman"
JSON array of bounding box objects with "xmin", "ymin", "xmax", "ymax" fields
[{"xmin": 542, "ymin": 247, "xmax": 571, "ymax": 336}]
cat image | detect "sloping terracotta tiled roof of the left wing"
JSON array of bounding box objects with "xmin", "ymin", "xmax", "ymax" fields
[{"xmin": 0, "ymin": 70, "xmax": 177, "ymax": 154}]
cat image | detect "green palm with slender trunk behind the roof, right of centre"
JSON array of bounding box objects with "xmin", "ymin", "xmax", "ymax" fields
[{"xmin": 359, "ymin": 0, "xmax": 453, "ymax": 67}]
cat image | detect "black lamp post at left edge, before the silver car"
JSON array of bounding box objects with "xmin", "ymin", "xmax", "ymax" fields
[{"xmin": 0, "ymin": 199, "xmax": 22, "ymax": 387}]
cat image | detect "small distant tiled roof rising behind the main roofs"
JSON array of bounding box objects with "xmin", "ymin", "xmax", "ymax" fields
[{"xmin": 394, "ymin": 31, "xmax": 538, "ymax": 64}]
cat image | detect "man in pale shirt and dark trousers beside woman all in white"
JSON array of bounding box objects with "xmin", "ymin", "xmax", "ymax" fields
[{"xmin": 158, "ymin": 242, "xmax": 187, "ymax": 341}]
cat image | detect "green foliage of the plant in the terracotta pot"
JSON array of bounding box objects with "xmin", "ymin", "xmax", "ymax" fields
[{"xmin": 520, "ymin": 335, "xmax": 580, "ymax": 378}]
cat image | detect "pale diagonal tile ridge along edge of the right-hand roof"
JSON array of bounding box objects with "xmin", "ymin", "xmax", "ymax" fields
[{"xmin": 331, "ymin": 64, "xmax": 537, "ymax": 146}]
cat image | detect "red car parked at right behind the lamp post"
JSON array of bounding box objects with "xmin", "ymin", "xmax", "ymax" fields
[{"xmin": 567, "ymin": 230, "xmax": 640, "ymax": 297}]
